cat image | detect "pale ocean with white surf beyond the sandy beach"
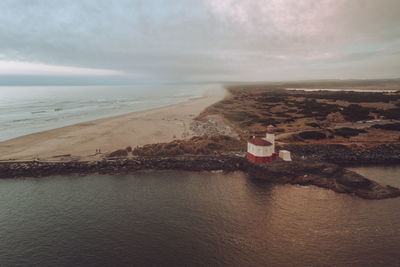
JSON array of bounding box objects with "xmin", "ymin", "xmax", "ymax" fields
[{"xmin": 0, "ymin": 84, "xmax": 219, "ymax": 141}]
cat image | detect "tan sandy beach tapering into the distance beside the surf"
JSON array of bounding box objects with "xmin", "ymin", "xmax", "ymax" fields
[{"xmin": 0, "ymin": 87, "xmax": 226, "ymax": 160}]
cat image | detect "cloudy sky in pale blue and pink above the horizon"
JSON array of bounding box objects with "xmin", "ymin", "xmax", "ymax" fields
[{"xmin": 0, "ymin": 0, "xmax": 400, "ymax": 84}]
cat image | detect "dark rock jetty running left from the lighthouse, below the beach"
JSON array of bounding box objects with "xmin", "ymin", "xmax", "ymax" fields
[{"xmin": 0, "ymin": 155, "xmax": 246, "ymax": 178}]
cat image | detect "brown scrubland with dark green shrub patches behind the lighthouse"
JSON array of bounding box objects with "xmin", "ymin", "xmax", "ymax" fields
[{"xmin": 198, "ymin": 80, "xmax": 400, "ymax": 145}]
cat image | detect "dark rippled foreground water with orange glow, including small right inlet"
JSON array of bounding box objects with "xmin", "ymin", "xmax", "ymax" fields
[{"xmin": 0, "ymin": 166, "xmax": 400, "ymax": 266}]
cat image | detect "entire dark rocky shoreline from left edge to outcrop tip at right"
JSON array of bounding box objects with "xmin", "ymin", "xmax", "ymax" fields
[{"xmin": 0, "ymin": 155, "xmax": 400, "ymax": 199}]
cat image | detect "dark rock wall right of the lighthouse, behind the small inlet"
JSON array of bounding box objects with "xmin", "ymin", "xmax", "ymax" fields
[{"xmin": 284, "ymin": 144, "xmax": 400, "ymax": 165}]
